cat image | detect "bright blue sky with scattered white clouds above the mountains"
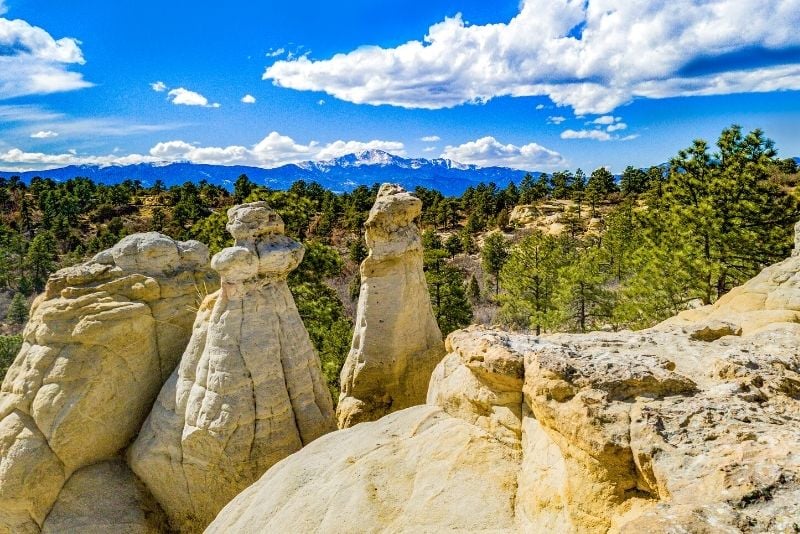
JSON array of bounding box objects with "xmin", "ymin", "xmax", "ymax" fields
[{"xmin": 0, "ymin": 0, "xmax": 800, "ymax": 171}]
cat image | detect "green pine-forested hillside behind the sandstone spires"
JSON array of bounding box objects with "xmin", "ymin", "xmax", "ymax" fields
[{"xmin": 0, "ymin": 126, "xmax": 800, "ymax": 390}]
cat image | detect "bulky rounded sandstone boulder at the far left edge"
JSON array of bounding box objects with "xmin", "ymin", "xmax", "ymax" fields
[{"xmin": 0, "ymin": 233, "xmax": 216, "ymax": 533}]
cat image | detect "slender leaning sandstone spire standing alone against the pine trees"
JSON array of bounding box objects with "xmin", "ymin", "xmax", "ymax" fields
[{"xmin": 336, "ymin": 184, "xmax": 444, "ymax": 428}]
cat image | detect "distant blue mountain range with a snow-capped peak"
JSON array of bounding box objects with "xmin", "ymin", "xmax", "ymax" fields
[{"xmin": 0, "ymin": 150, "xmax": 541, "ymax": 195}]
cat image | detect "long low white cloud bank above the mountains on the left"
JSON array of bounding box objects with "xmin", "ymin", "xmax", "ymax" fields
[{"xmin": 0, "ymin": 132, "xmax": 405, "ymax": 171}]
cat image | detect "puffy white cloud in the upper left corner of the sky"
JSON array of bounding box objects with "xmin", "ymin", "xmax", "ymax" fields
[{"xmin": 0, "ymin": 11, "xmax": 92, "ymax": 100}]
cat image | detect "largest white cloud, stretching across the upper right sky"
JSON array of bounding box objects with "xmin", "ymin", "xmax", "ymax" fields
[{"xmin": 263, "ymin": 0, "xmax": 800, "ymax": 115}]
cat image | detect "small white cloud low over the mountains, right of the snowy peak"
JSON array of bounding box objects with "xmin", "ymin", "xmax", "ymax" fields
[{"xmin": 442, "ymin": 136, "xmax": 566, "ymax": 170}]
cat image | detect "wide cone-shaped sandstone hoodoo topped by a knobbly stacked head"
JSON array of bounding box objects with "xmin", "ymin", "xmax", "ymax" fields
[{"xmin": 128, "ymin": 202, "xmax": 336, "ymax": 532}]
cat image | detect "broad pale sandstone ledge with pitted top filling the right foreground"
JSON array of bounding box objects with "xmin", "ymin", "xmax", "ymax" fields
[{"xmin": 209, "ymin": 257, "xmax": 800, "ymax": 534}]
